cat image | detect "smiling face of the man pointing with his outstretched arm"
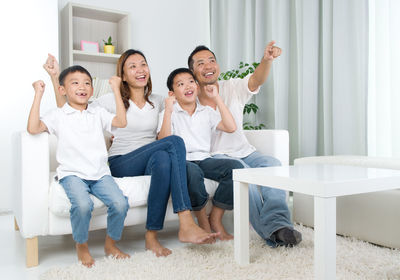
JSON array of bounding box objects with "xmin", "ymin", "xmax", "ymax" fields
[{"xmin": 193, "ymin": 50, "xmax": 219, "ymax": 85}]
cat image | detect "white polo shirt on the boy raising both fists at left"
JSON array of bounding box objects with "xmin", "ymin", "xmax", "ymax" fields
[{"xmin": 41, "ymin": 103, "xmax": 114, "ymax": 180}]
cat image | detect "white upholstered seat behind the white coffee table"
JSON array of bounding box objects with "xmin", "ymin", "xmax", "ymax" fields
[{"xmin": 293, "ymin": 156, "xmax": 400, "ymax": 248}]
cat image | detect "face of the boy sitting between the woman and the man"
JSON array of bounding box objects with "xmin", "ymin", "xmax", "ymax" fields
[{"xmin": 170, "ymin": 73, "xmax": 197, "ymax": 104}]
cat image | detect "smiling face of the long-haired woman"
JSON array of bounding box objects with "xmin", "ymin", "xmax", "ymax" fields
[{"xmin": 122, "ymin": 54, "xmax": 150, "ymax": 88}]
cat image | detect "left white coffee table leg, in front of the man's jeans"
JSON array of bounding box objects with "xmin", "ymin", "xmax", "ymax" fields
[{"xmin": 233, "ymin": 181, "xmax": 249, "ymax": 265}]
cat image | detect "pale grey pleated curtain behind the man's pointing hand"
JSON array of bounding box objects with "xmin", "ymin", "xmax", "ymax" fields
[{"xmin": 210, "ymin": 0, "xmax": 368, "ymax": 162}]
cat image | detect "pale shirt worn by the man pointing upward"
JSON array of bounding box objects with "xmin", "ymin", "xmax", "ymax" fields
[{"xmin": 211, "ymin": 75, "xmax": 260, "ymax": 158}]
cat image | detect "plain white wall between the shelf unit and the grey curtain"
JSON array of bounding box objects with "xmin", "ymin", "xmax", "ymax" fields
[{"xmin": 59, "ymin": 0, "xmax": 210, "ymax": 95}]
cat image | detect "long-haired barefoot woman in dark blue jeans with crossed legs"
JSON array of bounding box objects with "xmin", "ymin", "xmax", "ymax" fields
[{"xmin": 44, "ymin": 49, "xmax": 218, "ymax": 256}]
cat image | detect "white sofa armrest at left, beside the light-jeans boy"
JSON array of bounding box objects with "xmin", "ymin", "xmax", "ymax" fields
[{"xmin": 12, "ymin": 131, "xmax": 50, "ymax": 238}]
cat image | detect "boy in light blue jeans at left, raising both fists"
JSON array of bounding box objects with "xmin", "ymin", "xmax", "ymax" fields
[{"xmin": 28, "ymin": 65, "xmax": 129, "ymax": 267}]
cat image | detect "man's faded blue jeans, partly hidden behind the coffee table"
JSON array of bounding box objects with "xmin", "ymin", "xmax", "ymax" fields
[{"xmin": 214, "ymin": 151, "xmax": 293, "ymax": 247}]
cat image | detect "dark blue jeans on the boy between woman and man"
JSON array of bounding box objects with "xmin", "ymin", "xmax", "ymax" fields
[{"xmin": 186, "ymin": 158, "xmax": 243, "ymax": 211}]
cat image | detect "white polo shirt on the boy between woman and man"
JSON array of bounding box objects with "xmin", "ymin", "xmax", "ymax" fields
[{"xmin": 157, "ymin": 102, "xmax": 221, "ymax": 161}]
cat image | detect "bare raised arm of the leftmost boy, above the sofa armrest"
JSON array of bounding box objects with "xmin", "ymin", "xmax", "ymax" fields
[{"xmin": 27, "ymin": 81, "xmax": 47, "ymax": 134}]
